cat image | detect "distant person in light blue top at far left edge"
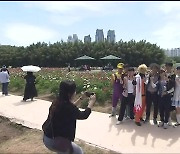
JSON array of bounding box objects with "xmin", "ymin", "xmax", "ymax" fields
[{"xmin": 0, "ymin": 68, "xmax": 10, "ymax": 96}]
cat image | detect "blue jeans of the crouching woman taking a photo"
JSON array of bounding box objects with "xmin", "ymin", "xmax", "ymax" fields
[{"xmin": 43, "ymin": 135, "xmax": 83, "ymax": 154}]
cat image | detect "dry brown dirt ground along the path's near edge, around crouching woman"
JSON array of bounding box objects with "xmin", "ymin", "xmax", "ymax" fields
[{"xmin": 0, "ymin": 116, "xmax": 118, "ymax": 154}]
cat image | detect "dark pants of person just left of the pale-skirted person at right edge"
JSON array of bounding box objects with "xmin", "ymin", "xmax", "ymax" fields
[{"xmin": 159, "ymin": 95, "xmax": 171, "ymax": 123}]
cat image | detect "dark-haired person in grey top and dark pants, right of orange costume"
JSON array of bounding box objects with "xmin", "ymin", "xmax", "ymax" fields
[{"xmin": 145, "ymin": 63, "xmax": 160, "ymax": 125}]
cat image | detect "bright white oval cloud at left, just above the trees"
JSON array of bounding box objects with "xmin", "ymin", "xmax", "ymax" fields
[{"xmin": 4, "ymin": 23, "xmax": 57, "ymax": 46}]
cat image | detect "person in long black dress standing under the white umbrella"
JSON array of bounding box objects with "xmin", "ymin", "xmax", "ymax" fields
[{"xmin": 23, "ymin": 72, "xmax": 37, "ymax": 101}]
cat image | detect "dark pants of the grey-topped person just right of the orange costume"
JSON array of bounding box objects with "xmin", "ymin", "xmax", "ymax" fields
[{"xmin": 146, "ymin": 91, "xmax": 158, "ymax": 120}]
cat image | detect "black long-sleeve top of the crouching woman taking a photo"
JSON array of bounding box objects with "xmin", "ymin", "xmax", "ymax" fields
[{"xmin": 42, "ymin": 102, "xmax": 91, "ymax": 141}]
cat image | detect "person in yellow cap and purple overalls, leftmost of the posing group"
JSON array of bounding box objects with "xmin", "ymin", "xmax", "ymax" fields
[{"xmin": 110, "ymin": 63, "xmax": 124, "ymax": 117}]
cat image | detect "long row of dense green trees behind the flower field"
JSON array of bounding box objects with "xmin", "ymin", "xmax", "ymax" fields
[{"xmin": 0, "ymin": 40, "xmax": 166, "ymax": 67}]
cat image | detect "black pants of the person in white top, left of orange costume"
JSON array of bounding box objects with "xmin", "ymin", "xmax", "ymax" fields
[{"xmin": 118, "ymin": 94, "xmax": 135, "ymax": 121}]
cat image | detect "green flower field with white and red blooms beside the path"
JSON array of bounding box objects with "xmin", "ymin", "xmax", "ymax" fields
[{"xmin": 9, "ymin": 68, "xmax": 112, "ymax": 105}]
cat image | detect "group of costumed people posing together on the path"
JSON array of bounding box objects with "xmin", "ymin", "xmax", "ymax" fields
[{"xmin": 110, "ymin": 63, "xmax": 180, "ymax": 129}]
